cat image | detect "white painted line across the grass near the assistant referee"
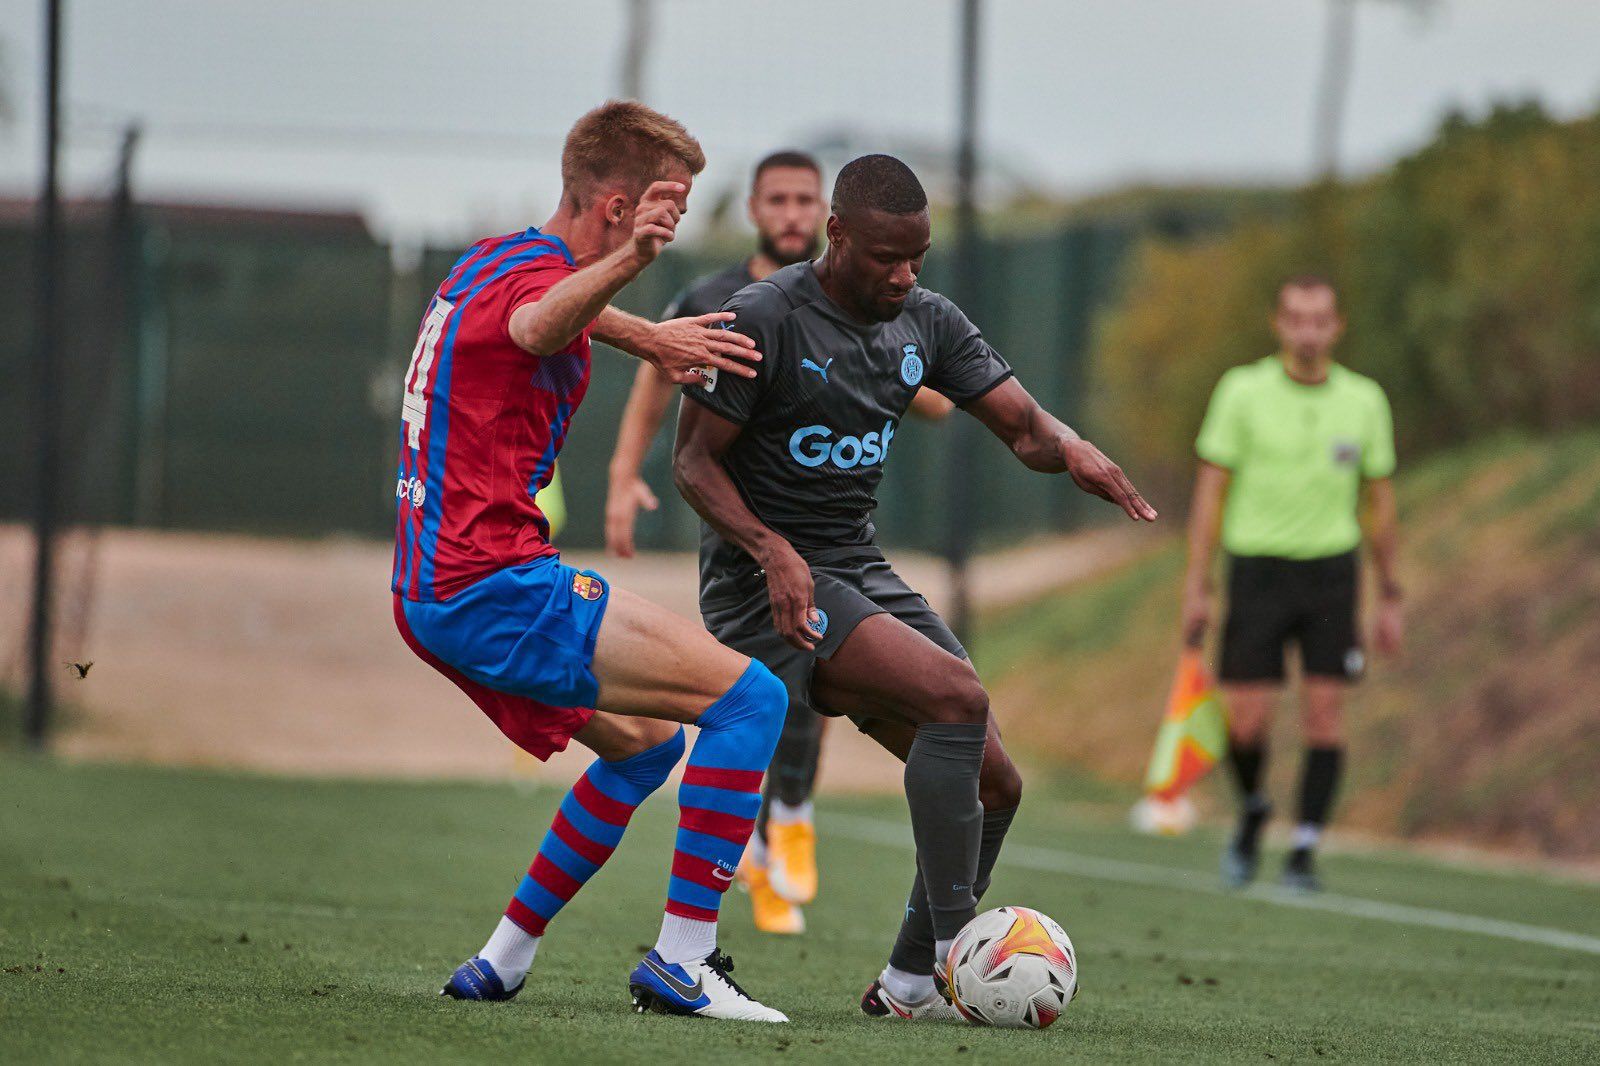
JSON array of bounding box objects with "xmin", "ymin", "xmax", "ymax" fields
[{"xmin": 821, "ymin": 815, "xmax": 1600, "ymax": 956}]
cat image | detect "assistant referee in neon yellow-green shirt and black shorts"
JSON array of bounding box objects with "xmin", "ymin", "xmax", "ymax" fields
[{"xmin": 1182, "ymin": 275, "xmax": 1403, "ymax": 892}]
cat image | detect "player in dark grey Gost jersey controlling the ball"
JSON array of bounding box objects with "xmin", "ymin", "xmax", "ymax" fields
[{"xmin": 674, "ymin": 155, "xmax": 1155, "ymax": 1018}]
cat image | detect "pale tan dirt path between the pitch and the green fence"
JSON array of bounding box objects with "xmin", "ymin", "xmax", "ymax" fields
[{"xmin": 0, "ymin": 527, "xmax": 1141, "ymax": 791}]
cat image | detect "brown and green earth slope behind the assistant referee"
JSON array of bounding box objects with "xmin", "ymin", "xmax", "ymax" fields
[{"xmin": 978, "ymin": 431, "xmax": 1600, "ymax": 858}]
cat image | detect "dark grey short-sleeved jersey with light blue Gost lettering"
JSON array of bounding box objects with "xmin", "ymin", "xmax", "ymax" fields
[{"xmin": 685, "ymin": 262, "xmax": 1011, "ymax": 595}]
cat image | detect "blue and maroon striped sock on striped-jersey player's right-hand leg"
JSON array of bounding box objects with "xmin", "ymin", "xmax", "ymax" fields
[{"xmin": 656, "ymin": 661, "xmax": 789, "ymax": 964}]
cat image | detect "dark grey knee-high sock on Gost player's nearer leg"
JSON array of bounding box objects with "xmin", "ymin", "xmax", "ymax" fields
[{"xmin": 906, "ymin": 722, "xmax": 989, "ymax": 940}]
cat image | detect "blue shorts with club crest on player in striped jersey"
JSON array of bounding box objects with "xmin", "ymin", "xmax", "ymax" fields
[{"xmin": 395, "ymin": 555, "xmax": 611, "ymax": 720}]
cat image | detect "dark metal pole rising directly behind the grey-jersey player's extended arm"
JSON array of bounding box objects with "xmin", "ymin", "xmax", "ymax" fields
[{"xmin": 944, "ymin": 0, "xmax": 982, "ymax": 650}]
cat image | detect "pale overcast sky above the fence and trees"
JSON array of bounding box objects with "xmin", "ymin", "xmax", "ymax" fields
[{"xmin": 0, "ymin": 0, "xmax": 1600, "ymax": 237}]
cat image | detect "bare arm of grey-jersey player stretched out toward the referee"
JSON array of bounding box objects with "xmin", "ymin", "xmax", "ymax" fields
[{"xmin": 966, "ymin": 378, "xmax": 1155, "ymax": 522}]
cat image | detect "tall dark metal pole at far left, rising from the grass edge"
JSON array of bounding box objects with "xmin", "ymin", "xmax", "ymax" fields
[{"xmin": 26, "ymin": 0, "xmax": 62, "ymax": 751}]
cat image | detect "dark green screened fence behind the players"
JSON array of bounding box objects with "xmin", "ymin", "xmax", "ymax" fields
[{"xmin": 0, "ymin": 206, "xmax": 1196, "ymax": 549}]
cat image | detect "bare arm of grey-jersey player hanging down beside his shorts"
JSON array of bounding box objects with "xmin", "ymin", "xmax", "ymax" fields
[{"xmin": 672, "ymin": 400, "xmax": 821, "ymax": 651}]
